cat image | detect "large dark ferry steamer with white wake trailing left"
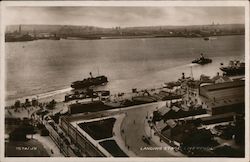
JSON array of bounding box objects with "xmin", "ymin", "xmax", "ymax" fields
[{"xmin": 71, "ymin": 72, "xmax": 108, "ymax": 89}]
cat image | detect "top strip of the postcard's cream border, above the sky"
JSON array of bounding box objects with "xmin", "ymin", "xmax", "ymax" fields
[{"xmin": 2, "ymin": 1, "xmax": 248, "ymax": 7}]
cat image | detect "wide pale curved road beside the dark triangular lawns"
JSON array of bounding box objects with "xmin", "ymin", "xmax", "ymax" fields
[{"xmin": 121, "ymin": 102, "xmax": 179, "ymax": 157}]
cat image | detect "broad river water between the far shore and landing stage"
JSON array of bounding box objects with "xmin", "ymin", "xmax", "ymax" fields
[{"xmin": 5, "ymin": 36, "xmax": 245, "ymax": 100}]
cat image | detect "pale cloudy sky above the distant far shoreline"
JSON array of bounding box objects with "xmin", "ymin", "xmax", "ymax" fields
[{"xmin": 5, "ymin": 6, "xmax": 244, "ymax": 27}]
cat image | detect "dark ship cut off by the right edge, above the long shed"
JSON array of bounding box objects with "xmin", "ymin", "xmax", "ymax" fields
[{"xmin": 220, "ymin": 60, "xmax": 245, "ymax": 76}]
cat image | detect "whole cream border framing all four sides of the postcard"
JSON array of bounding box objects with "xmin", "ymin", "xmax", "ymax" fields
[{"xmin": 0, "ymin": 1, "xmax": 250, "ymax": 162}]
